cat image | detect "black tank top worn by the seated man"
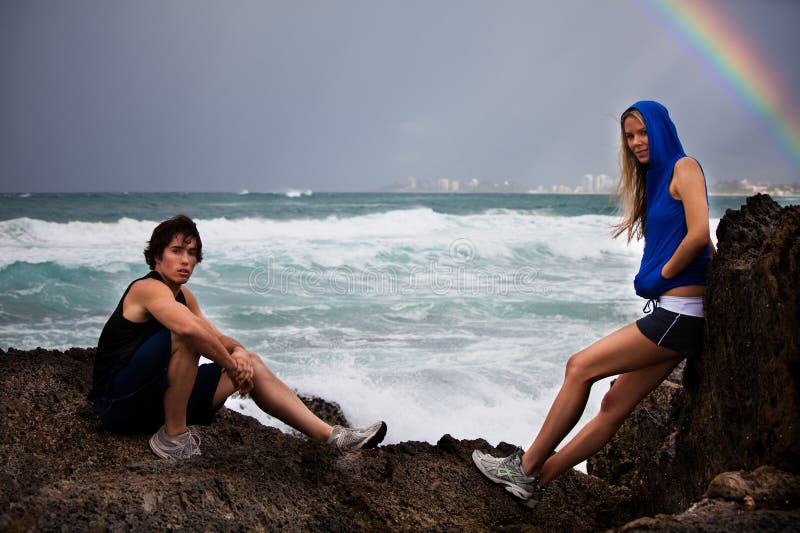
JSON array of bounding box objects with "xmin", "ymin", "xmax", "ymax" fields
[{"xmin": 89, "ymin": 271, "xmax": 186, "ymax": 399}]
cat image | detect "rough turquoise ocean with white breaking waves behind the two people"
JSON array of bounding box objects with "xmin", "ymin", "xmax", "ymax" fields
[{"xmin": 0, "ymin": 191, "xmax": 798, "ymax": 456}]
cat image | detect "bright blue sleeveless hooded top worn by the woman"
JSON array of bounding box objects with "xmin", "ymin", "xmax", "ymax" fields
[{"xmin": 629, "ymin": 100, "xmax": 711, "ymax": 299}]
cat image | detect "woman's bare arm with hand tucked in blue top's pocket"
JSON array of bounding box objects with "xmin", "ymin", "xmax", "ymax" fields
[{"xmin": 661, "ymin": 157, "xmax": 710, "ymax": 279}]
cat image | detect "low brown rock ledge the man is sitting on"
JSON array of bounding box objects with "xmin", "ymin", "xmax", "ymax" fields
[{"xmin": 0, "ymin": 349, "xmax": 635, "ymax": 531}]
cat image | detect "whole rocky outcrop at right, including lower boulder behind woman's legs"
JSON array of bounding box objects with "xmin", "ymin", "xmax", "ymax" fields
[{"xmin": 588, "ymin": 195, "xmax": 800, "ymax": 528}]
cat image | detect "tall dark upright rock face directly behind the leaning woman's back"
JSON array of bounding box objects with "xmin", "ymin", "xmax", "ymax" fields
[{"xmin": 676, "ymin": 195, "xmax": 800, "ymax": 478}]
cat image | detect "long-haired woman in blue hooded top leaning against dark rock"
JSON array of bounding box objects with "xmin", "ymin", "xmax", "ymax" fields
[{"xmin": 472, "ymin": 101, "xmax": 713, "ymax": 507}]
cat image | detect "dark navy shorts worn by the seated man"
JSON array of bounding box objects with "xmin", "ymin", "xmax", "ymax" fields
[{"xmin": 94, "ymin": 329, "xmax": 222, "ymax": 434}]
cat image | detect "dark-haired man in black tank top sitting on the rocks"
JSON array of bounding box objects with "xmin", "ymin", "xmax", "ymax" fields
[{"xmin": 89, "ymin": 215, "xmax": 386, "ymax": 460}]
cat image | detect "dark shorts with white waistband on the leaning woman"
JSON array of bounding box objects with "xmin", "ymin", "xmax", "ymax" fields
[{"xmin": 636, "ymin": 307, "xmax": 704, "ymax": 359}]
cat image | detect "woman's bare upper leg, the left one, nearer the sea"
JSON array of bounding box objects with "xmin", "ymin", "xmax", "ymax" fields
[{"xmin": 522, "ymin": 324, "xmax": 681, "ymax": 474}]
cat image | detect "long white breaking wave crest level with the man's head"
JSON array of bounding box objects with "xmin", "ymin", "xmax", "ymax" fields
[{"xmin": 0, "ymin": 208, "xmax": 719, "ymax": 268}]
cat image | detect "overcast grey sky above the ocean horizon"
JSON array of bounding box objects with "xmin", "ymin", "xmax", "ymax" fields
[{"xmin": 0, "ymin": 0, "xmax": 800, "ymax": 192}]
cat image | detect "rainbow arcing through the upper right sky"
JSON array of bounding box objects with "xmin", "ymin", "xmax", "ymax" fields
[{"xmin": 650, "ymin": 0, "xmax": 800, "ymax": 177}]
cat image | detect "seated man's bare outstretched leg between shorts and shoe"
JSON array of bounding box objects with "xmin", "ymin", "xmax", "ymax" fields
[{"xmin": 214, "ymin": 352, "xmax": 331, "ymax": 440}]
